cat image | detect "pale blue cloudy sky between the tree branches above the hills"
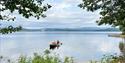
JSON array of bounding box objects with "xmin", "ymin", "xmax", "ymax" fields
[{"xmin": 1, "ymin": 0, "xmax": 108, "ymax": 28}]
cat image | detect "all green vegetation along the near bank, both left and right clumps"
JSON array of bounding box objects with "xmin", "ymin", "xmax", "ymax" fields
[{"xmin": 0, "ymin": 50, "xmax": 125, "ymax": 63}]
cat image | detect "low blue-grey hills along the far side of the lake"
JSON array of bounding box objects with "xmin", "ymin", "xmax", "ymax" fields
[{"xmin": 22, "ymin": 27, "xmax": 120, "ymax": 32}]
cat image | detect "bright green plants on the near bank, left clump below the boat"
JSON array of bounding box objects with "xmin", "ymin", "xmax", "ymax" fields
[{"xmin": 0, "ymin": 50, "xmax": 74, "ymax": 63}]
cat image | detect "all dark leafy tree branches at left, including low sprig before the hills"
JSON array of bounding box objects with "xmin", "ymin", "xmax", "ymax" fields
[{"xmin": 0, "ymin": 0, "xmax": 51, "ymax": 34}]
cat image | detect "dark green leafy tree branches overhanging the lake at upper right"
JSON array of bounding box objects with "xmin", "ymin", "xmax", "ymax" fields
[{"xmin": 78, "ymin": 0, "xmax": 125, "ymax": 34}]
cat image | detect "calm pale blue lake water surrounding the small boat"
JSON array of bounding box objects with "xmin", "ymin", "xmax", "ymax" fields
[{"xmin": 0, "ymin": 32, "xmax": 121, "ymax": 61}]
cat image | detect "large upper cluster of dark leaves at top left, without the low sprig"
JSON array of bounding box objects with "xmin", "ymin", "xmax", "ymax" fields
[{"xmin": 0, "ymin": 0, "xmax": 51, "ymax": 20}]
